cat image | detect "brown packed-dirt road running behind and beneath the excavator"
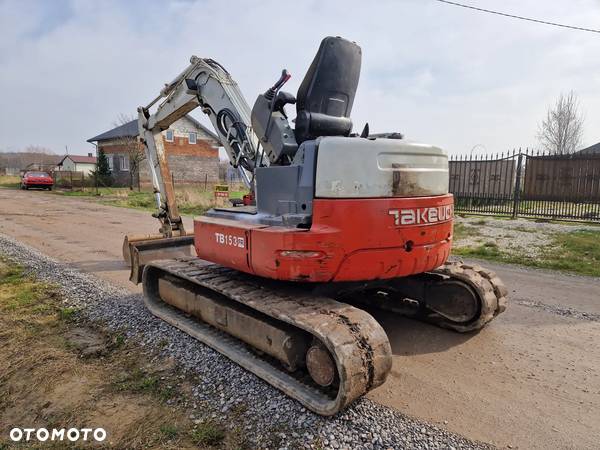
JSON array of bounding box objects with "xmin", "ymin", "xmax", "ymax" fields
[{"xmin": 0, "ymin": 189, "xmax": 600, "ymax": 449}]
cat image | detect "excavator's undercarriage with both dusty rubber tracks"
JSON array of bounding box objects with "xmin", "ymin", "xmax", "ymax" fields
[{"xmin": 143, "ymin": 258, "xmax": 506, "ymax": 415}]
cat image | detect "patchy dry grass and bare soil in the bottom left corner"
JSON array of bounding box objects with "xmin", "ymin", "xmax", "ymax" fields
[{"xmin": 0, "ymin": 255, "xmax": 247, "ymax": 449}]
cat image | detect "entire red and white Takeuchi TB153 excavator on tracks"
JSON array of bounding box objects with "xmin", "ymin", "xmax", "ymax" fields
[{"xmin": 124, "ymin": 37, "xmax": 507, "ymax": 415}]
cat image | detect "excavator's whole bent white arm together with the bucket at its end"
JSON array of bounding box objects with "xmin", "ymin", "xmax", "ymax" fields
[{"xmin": 123, "ymin": 56, "xmax": 268, "ymax": 274}]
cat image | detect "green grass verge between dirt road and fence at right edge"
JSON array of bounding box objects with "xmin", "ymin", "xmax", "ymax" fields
[{"xmin": 453, "ymin": 230, "xmax": 600, "ymax": 277}]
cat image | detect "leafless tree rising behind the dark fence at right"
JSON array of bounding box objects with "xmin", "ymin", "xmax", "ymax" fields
[{"xmin": 538, "ymin": 91, "xmax": 583, "ymax": 155}]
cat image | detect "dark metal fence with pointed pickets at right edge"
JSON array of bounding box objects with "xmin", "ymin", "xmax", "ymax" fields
[{"xmin": 449, "ymin": 149, "xmax": 600, "ymax": 222}]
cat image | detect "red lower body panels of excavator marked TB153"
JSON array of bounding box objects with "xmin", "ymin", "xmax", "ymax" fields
[{"xmin": 194, "ymin": 194, "xmax": 453, "ymax": 282}]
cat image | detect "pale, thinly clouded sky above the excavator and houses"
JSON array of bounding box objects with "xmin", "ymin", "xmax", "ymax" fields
[{"xmin": 0, "ymin": 0, "xmax": 600, "ymax": 154}]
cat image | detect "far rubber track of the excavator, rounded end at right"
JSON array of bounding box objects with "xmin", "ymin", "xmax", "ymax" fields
[{"xmin": 426, "ymin": 261, "xmax": 508, "ymax": 333}]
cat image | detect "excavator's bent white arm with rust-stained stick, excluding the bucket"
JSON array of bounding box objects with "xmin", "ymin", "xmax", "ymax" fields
[{"xmin": 138, "ymin": 56, "xmax": 268, "ymax": 238}]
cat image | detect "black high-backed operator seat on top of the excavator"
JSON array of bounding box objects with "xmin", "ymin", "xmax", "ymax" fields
[{"xmin": 294, "ymin": 36, "xmax": 361, "ymax": 145}]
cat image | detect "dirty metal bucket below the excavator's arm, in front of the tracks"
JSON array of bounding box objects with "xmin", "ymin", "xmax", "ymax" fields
[{"xmin": 123, "ymin": 234, "xmax": 194, "ymax": 284}]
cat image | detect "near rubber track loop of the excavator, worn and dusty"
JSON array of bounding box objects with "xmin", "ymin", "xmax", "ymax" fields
[{"xmin": 143, "ymin": 258, "xmax": 392, "ymax": 415}]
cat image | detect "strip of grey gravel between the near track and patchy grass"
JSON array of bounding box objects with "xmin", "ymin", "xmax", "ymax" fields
[{"xmin": 0, "ymin": 234, "xmax": 491, "ymax": 449}]
